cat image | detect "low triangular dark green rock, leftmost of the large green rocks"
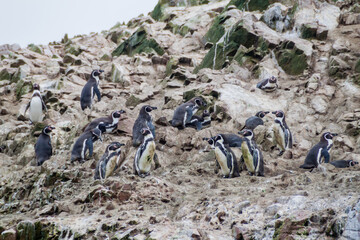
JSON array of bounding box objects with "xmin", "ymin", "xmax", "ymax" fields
[{"xmin": 112, "ymin": 27, "xmax": 164, "ymax": 57}]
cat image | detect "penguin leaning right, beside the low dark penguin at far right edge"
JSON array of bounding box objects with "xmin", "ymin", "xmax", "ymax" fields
[{"xmin": 300, "ymin": 132, "xmax": 337, "ymax": 169}]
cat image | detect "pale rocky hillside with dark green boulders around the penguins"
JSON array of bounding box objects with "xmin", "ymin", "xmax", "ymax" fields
[{"xmin": 0, "ymin": 0, "xmax": 360, "ymax": 239}]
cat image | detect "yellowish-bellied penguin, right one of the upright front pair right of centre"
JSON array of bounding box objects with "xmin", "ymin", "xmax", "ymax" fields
[{"xmin": 239, "ymin": 129, "xmax": 264, "ymax": 176}]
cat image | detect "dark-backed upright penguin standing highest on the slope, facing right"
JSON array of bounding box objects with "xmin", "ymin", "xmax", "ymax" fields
[{"xmin": 80, "ymin": 70, "xmax": 104, "ymax": 111}]
